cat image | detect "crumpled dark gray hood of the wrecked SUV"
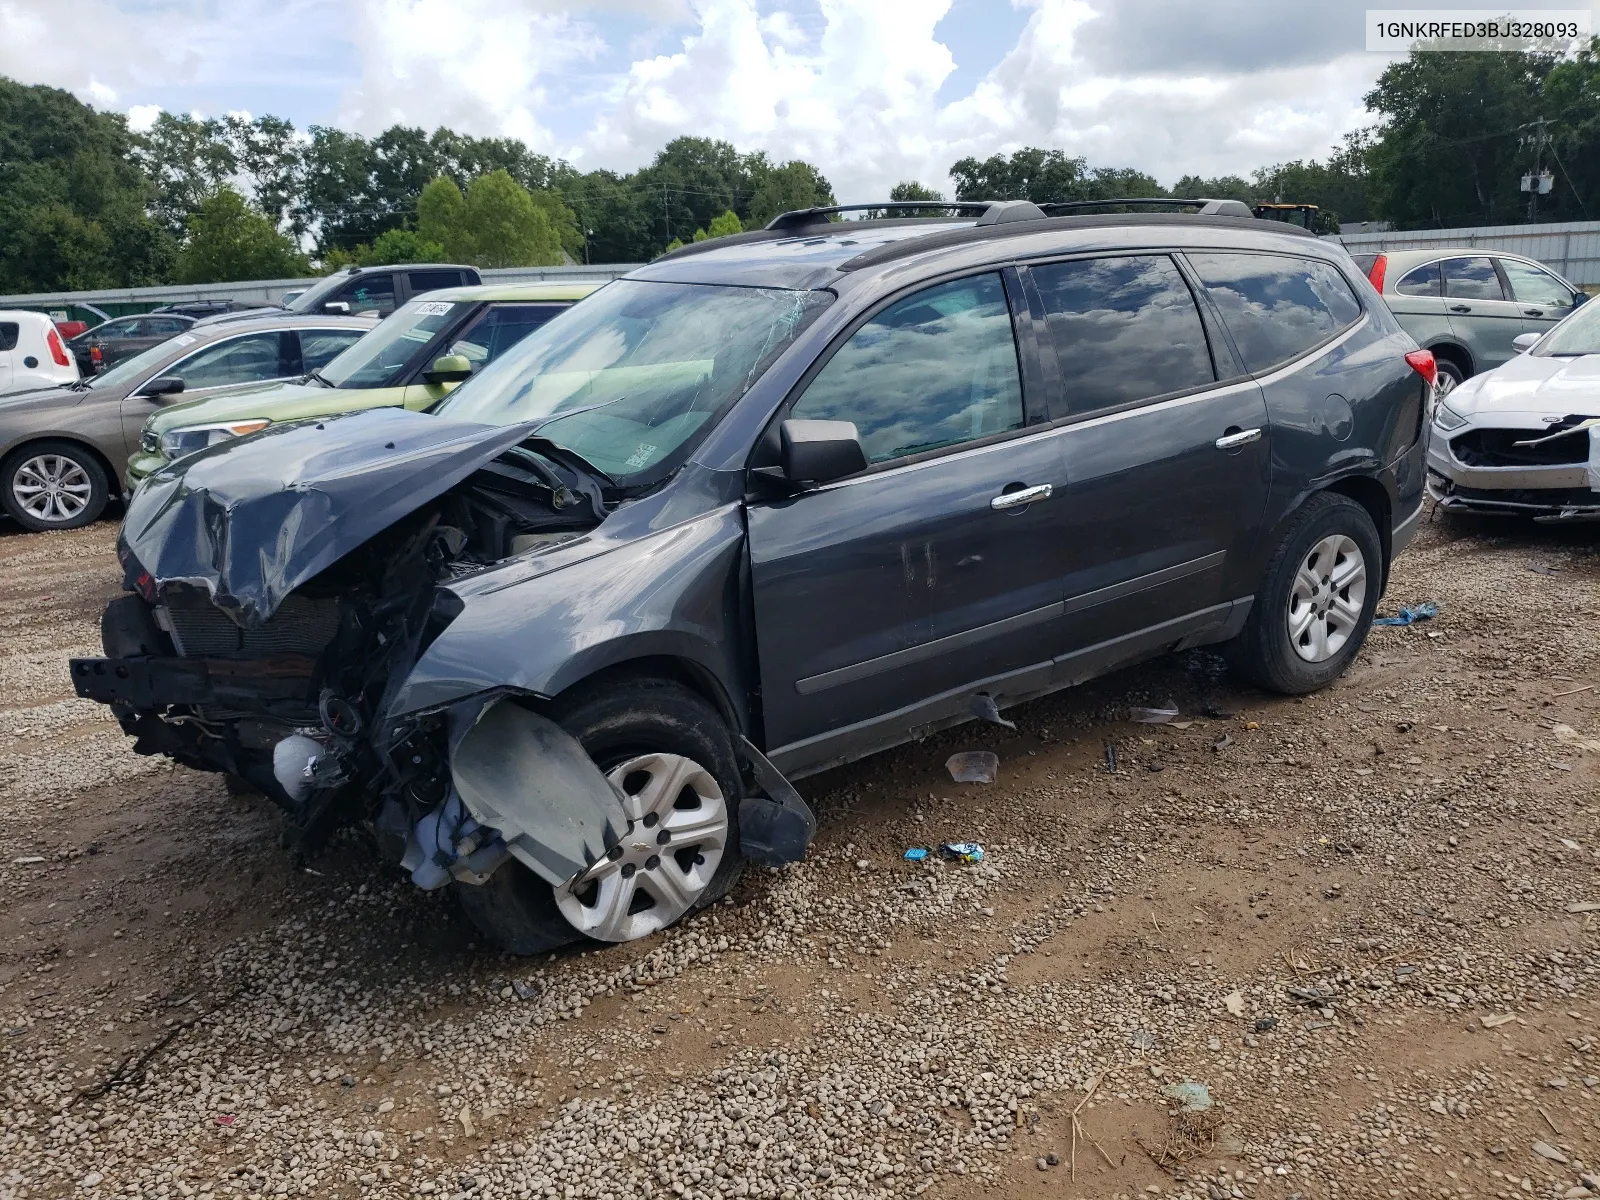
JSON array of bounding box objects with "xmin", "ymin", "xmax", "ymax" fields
[{"xmin": 118, "ymin": 408, "xmax": 530, "ymax": 629}]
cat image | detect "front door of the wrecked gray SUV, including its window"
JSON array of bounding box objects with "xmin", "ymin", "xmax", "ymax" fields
[{"xmin": 749, "ymin": 274, "xmax": 1062, "ymax": 752}]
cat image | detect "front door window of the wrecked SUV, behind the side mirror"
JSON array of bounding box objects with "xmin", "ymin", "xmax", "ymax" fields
[{"xmin": 790, "ymin": 274, "xmax": 1022, "ymax": 462}]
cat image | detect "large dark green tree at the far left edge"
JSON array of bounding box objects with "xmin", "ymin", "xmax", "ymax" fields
[{"xmin": 0, "ymin": 78, "xmax": 176, "ymax": 291}]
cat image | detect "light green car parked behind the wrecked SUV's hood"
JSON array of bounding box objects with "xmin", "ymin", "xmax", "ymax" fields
[{"xmin": 126, "ymin": 283, "xmax": 600, "ymax": 493}]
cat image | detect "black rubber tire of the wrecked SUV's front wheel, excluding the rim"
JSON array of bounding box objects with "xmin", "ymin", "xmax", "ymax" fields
[{"xmin": 454, "ymin": 677, "xmax": 744, "ymax": 954}]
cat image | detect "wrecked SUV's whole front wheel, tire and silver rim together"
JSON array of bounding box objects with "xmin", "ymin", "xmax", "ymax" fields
[{"xmin": 456, "ymin": 677, "xmax": 742, "ymax": 954}]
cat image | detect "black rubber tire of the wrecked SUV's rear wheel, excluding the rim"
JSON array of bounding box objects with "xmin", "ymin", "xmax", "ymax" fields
[{"xmin": 1227, "ymin": 491, "xmax": 1384, "ymax": 696}]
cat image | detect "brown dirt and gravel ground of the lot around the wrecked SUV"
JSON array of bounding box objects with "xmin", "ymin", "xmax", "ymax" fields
[{"xmin": 0, "ymin": 517, "xmax": 1600, "ymax": 1200}]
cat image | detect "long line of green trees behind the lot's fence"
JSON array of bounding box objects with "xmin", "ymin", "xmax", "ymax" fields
[{"xmin": 9, "ymin": 40, "xmax": 1600, "ymax": 293}]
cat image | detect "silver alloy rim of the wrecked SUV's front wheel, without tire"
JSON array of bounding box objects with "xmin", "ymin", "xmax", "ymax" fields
[{"xmin": 555, "ymin": 754, "xmax": 728, "ymax": 942}]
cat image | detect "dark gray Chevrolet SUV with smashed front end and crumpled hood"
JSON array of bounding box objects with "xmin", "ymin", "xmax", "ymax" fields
[{"xmin": 72, "ymin": 202, "xmax": 1432, "ymax": 952}]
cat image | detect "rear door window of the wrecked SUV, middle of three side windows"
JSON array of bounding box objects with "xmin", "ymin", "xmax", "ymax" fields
[{"xmin": 1030, "ymin": 254, "xmax": 1216, "ymax": 414}]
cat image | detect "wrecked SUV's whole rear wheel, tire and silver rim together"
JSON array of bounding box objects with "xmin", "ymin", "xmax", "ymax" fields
[{"xmin": 1229, "ymin": 491, "xmax": 1384, "ymax": 696}]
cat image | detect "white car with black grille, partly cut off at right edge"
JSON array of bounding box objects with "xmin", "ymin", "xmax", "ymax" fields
[{"xmin": 1427, "ymin": 296, "xmax": 1600, "ymax": 522}]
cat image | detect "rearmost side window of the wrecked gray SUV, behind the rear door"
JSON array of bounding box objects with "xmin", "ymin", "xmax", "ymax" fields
[{"xmin": 1187, "ymin": 253, "xmax": 1362, "ymax": 374}]
